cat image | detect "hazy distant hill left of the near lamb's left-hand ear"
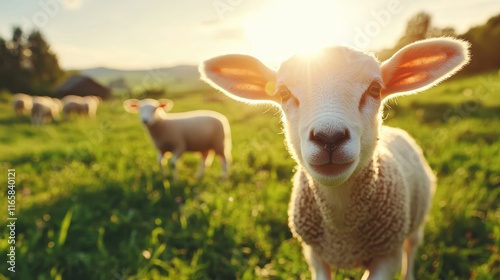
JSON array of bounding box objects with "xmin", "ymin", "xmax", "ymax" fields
[{"xmin": 79, "ymin": 65, "xmax": 206, "ymax": 92}]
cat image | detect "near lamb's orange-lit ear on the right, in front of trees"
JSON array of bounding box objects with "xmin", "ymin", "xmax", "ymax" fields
[{"xmin": 382, "ymin": 38, "xmax": 470, "ymax": 98}]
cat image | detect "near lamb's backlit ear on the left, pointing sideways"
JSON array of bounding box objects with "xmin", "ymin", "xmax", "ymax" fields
[{"xmin": 199, "ymin": 55, "xmax": 281, "ymax": 104}]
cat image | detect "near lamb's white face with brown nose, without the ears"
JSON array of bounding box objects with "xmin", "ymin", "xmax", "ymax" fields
[{"xmin": 275, "ymin": 47, "xmax": 382, "ymax": 186}]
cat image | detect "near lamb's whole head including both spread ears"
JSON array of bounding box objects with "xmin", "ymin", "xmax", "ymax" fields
[{"xmin": 200, "ymin": 38, "xmax": 468, "ymax": 186}]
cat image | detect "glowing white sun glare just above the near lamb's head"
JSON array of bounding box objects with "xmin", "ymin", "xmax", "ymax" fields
[{"xmin": 244, "ymin": 0, "xmax": 352, "ymax": 63}]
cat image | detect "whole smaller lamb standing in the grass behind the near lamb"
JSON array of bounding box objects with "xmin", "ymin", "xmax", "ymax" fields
[{"xmin": 123, "ymin": 99, "xmax": 231, "ymax": 180}]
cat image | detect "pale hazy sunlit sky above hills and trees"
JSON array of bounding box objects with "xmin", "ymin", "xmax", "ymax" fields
[{"xmin": 0, "ymin": 0, "xmax": 500, "ymax": 70}]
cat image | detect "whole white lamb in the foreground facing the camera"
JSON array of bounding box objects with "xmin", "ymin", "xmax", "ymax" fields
[{"xmin": 200, "ymin": 38, "xmax": 469, "ymax": 279}]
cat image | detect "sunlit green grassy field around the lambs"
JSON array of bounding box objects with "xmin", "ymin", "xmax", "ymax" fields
[{"xmin": 0, "ymin": 73, "xmax": 500, "ymax": 279}]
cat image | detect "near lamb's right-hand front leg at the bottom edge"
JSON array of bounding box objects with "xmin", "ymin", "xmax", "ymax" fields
[{"xmin": 361, "ymin": 248, "xmax": 403, "ymax": 280}]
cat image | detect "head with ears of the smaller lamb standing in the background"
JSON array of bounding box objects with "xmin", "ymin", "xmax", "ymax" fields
[{"xmin": 123, "ymin": 98, "xmax": 174, "ymax": 126}]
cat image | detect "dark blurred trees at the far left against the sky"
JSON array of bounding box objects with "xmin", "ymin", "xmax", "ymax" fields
[{"xmin": 0, "ymin": 27, "xmax": 64, "ymax": 95}]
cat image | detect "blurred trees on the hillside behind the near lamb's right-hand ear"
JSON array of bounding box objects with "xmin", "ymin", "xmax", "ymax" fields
[{"xmin": 377, "ymin": 12, "xmax": 500, "ymax": 75}]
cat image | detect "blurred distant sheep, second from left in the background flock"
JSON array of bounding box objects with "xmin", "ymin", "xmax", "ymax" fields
[{"xmin": 31, "ymin": 96, "xmax": 62, "ymax": 126}]
